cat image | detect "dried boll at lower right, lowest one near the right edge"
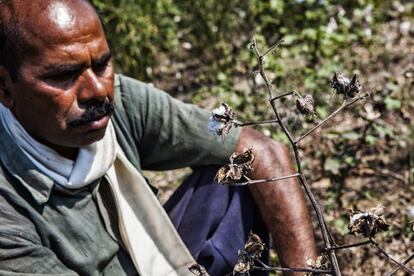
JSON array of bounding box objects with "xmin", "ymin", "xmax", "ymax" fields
[{"xmin": 348, "ymin": 205, "xmax": 389, "ymax": 238}]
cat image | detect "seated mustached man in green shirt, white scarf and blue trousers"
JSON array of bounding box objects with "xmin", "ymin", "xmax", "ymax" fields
[{"xmin": 0, "ymin": 0, "xmax": 316, "ymax": 275}]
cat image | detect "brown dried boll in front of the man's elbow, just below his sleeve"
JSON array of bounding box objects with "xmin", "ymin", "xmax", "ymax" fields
[{"xmin": 214, "ymin": 148, "xmax": 254, "ymax": 184}]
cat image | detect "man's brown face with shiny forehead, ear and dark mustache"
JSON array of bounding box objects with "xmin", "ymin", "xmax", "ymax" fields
[{"xmin": 2, "ymin": 1, "xmax": 114, "ymax": 153}]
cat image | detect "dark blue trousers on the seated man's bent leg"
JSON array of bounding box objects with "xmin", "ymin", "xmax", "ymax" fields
[{"xmin": 164, "ymin": 166, "xmax": 269, "ymax": 276}]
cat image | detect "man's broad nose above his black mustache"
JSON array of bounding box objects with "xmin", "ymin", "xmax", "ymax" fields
[{"xmin": 78, "ymin": 68, "xmax": 110, "ymax": 104}]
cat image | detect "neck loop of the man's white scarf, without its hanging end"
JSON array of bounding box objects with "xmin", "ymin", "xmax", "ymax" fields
[{"xmin": 0, "ymin": 104, "xmax": 116, "ymax": 189}]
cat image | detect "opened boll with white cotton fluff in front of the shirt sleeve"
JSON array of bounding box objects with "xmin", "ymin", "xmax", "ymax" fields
[{"xmin": 208, "ymin": 103, "xmax": 234, "ymax": 136}]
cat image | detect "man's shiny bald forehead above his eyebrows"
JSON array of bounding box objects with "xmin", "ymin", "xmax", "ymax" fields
[{"xmin": 21, "ymin": 0, "xmax": 108, "ymax": 62}]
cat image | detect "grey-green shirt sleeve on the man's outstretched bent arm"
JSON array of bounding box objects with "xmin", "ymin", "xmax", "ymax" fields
[{"xmin": 115, "ymin": 77, "xmax": 240, "ymax": 170}]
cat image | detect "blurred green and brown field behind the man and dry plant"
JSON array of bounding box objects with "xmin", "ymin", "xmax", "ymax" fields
[{"xmin": 94, "ymin": 0, "xmax": 414, "ymax": 275}]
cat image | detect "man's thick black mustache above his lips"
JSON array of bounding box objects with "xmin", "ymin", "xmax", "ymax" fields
[{"xmin": 68, "ymin": 101, "xmax": 114, "ymax": 128}]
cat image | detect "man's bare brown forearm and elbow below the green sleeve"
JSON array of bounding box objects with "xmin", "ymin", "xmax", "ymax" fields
[{"xmin": 236, "ymin": 128, "xmax": 317, "ymax": 268}]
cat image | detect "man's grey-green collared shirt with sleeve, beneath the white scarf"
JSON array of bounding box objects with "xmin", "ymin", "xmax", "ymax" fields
[{"xmin": 0, "ymin": 76, "xmax": 240, "ymax": 275}]
